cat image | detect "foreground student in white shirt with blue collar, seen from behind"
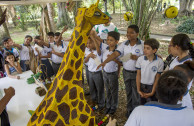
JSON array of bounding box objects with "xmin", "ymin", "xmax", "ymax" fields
[{"xmin": 125, "ymin": 70, "xmax": 194, "ymax": 126}]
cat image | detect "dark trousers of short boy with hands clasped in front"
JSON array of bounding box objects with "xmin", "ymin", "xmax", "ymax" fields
[{"xmin": 140, "ymin": 83, "xmax": 158, "ymax": 105}]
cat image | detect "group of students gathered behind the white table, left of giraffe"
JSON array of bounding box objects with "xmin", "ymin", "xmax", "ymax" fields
[{"xmin": 0, "ymin": 27, "xmax": 68, "ymax": 84}]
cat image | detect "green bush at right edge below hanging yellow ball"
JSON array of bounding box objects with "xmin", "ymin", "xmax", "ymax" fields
[{"xmin": 176, "ymin": 19, "xmax": 194, "ymax": 34}]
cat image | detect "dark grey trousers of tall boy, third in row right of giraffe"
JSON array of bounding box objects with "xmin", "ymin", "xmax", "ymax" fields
[{"xmin": 123, "ymin": 69, "xmax": 140, "ymax": 114}]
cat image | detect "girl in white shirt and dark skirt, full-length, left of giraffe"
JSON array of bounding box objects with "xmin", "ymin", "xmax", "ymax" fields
[{"xmin": 34, "ymin": 36, "xmax": 54, "ymax": 84}]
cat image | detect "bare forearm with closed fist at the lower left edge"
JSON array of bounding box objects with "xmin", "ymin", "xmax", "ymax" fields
[{"xmin": 0, "ymin": 87, "xmax": 15, "ymax": 114}]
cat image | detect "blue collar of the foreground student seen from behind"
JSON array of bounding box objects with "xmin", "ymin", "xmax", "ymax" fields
[{"xmin": 144, "ymin": 101, "xmax": 186, "ymax": 110}]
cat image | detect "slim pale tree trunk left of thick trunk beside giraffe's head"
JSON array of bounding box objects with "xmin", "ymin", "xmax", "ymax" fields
[{"xmin": 47, "ymin": 3, "xmax": 56, "ymax": 32}]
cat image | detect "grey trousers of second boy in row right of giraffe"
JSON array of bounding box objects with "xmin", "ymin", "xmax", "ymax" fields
[{"xmin": 103, "ymin": 72, "xmax": 119, "ymax": 110}]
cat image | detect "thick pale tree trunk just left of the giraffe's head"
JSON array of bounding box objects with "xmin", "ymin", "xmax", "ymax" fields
[{"xmin": 57, "ymin": 2, "xmax": 73, "ymax": 28}]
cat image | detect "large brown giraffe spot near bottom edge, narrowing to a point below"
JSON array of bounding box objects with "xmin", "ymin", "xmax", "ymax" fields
[{"xmin": 58, "ymin": 103, "xmax": 70, "ymax": 124}]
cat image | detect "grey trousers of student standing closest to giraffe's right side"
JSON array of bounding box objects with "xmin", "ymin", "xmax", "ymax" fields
[{"xmin": 89, "ymin": 71, "xmax": 105, "ymax": 107}]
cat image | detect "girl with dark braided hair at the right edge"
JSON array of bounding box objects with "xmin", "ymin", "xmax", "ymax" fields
[{"xmin": 169, "ymin": 34, "xmax": 194, "ymax": 70}]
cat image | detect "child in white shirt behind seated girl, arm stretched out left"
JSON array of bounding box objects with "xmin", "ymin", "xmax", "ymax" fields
[{"xmin": 10, "ymin": 35, "xmax": 33, "ymax": 71}]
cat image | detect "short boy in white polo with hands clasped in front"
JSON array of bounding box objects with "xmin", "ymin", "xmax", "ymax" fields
[{"xmin": 136, "ymin": 39, "xmax": 164, "ymax": 105}]
